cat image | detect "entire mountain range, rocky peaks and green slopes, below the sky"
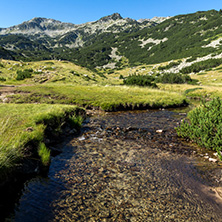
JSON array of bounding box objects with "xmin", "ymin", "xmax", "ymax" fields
[{"xmin": 0, "ymin": 10, "xmax": 222, "ymax": 69}]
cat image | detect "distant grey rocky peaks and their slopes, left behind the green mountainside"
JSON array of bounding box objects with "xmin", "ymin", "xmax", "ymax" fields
[{"xmin": 0, "ymin": 13, "xmax": 164, "ymax": 60}]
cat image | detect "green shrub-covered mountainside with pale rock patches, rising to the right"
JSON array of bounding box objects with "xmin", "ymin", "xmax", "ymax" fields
[{"xmin": 56, "ymin": 10, "xmax": 222, "ymax": 68}]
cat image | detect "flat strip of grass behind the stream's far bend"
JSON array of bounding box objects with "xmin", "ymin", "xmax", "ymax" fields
[{"xmin": 7, "ymin": 84, "xmax": 185, "ymax": 111}]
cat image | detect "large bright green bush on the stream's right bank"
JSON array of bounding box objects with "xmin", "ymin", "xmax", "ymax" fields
[{"xmin": 176, "ymin": 98, "xmax": 222, "ymax": 158}]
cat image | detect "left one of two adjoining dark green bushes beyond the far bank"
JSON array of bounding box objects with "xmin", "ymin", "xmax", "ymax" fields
[{"xmin": 123, "ymin": 74, "xmax": 157, "ymax": 88}]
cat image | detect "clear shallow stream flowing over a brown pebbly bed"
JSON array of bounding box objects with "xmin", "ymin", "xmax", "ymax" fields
[{"xmin": 5, "ymin": 110, "xmax": 222, "ymax": 222}]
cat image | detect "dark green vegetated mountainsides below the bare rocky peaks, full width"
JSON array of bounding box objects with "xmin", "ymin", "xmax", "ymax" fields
[{"xmin": 0, "ymin": 10, "xmax": 222, "ymax": 69}]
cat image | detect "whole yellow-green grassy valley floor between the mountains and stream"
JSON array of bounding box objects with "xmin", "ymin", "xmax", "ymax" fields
[{"xmin": 0, "ymin": 60, "xmax": 222, "ymax": 220}]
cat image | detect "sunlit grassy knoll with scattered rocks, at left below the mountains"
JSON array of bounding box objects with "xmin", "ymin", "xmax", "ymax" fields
[{"xmin": 0, "ymin": 60, "xmax": 103, "ymax": 85}]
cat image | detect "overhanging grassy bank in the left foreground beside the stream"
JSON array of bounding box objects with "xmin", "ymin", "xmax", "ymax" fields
[{"xmin": 0, "ymin": 104, "xmax": 84, "ymax": 180}]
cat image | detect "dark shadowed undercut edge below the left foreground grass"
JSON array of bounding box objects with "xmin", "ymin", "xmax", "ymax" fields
[{"xmin": 0, "ymin": 107, "xmax": 86, "ymax": 190}]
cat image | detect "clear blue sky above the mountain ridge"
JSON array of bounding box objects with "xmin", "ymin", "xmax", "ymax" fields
[{"xmin": 0, "ymin": 0, "xmax": 222, "ymax": 28}]
